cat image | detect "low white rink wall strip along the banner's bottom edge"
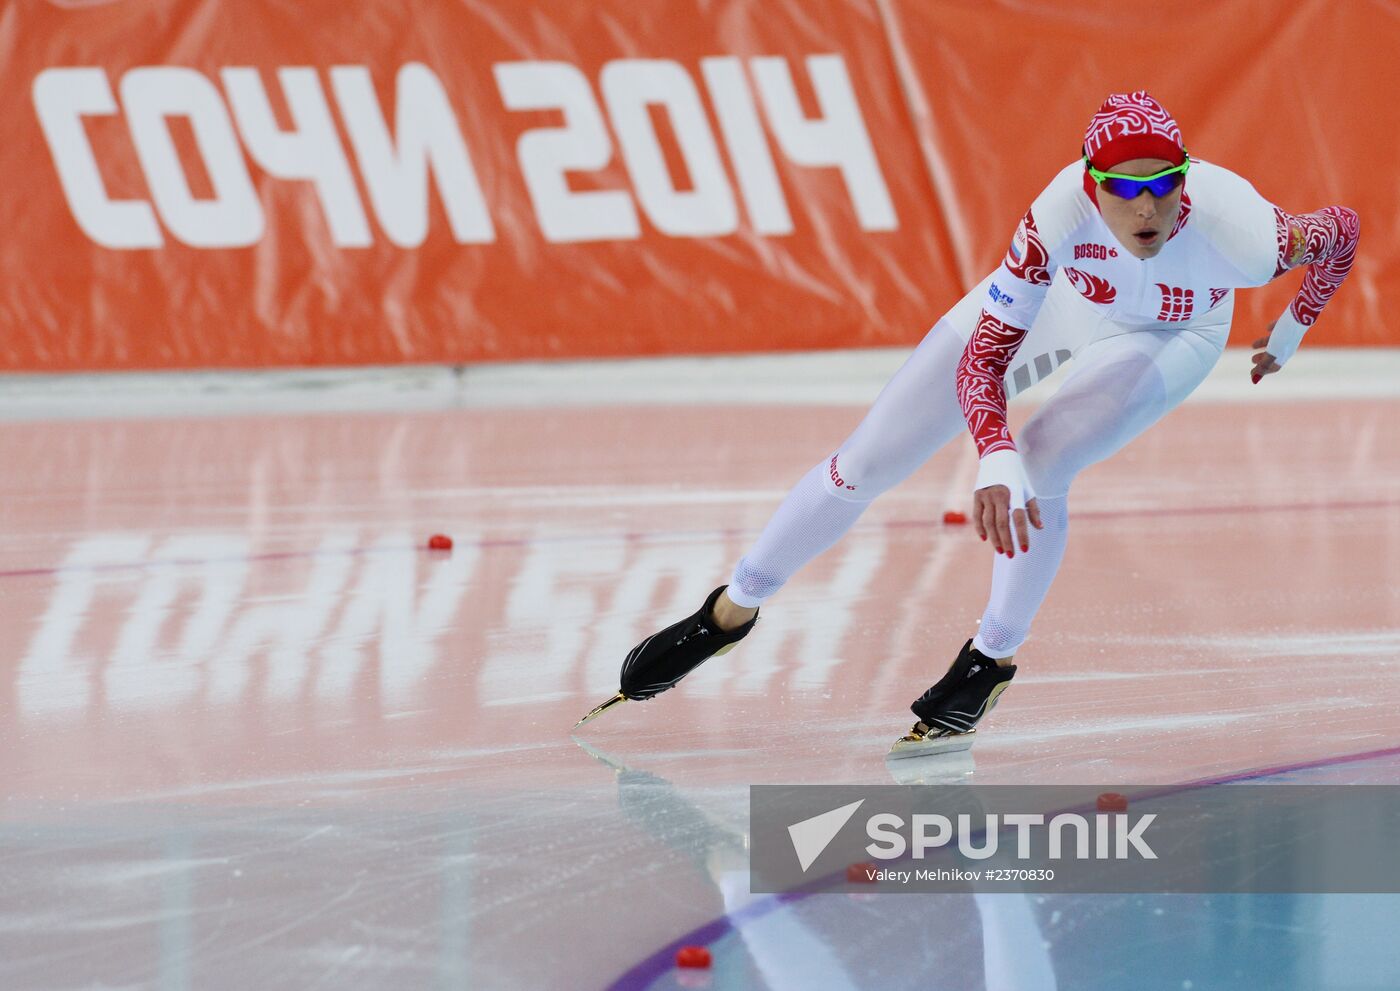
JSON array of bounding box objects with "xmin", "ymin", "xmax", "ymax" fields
[{"xmin": 0, "ymin": 347, "xmax": 1400, "ymax": 420}]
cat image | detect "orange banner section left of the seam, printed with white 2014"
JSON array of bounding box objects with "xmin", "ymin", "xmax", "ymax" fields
[{"xmin": 0, "ymin": 0, "xmax": 952, "ymax": 370}]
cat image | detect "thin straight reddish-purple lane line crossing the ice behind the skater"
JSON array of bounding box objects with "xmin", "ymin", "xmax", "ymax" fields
[{"xmin": 0, "ymin": 500, "xmax": 1400, "ymax": 578}]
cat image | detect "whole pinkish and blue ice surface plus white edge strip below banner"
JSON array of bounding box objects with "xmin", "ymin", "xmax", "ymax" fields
[{"xmin": 0, "ymin": 353, "xmax": 1400, "ymax": 991}]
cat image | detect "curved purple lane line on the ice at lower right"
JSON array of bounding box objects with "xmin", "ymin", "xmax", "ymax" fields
[{"xmin": 606, "ymin": 746, "xmax": 1400, "ymax": 991}]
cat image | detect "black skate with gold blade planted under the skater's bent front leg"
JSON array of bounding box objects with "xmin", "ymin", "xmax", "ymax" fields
[{"xmin": 889, "ymin": 640, "xmax": 1016, "ymax": 757}]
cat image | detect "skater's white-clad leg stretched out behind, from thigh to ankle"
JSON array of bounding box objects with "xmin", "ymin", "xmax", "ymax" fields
[{"xmin": 715, "ymin": 321, "xmax": 967, "ymax": 610}]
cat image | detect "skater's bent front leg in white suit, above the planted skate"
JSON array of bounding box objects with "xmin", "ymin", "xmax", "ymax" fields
[{"xmin": 973, "ymin": 323, "xmax": 1228, "ymax": 659}]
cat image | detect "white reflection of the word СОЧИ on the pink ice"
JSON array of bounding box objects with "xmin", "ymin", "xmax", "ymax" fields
[{"xmin": 18, "ymin": 532, "xmax": 480, "ymax": 715}]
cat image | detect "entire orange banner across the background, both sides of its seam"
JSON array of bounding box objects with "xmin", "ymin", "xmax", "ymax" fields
[{"xmin": 0, "ymin": 0, "xmax": 1400, "ymax": 371}]
